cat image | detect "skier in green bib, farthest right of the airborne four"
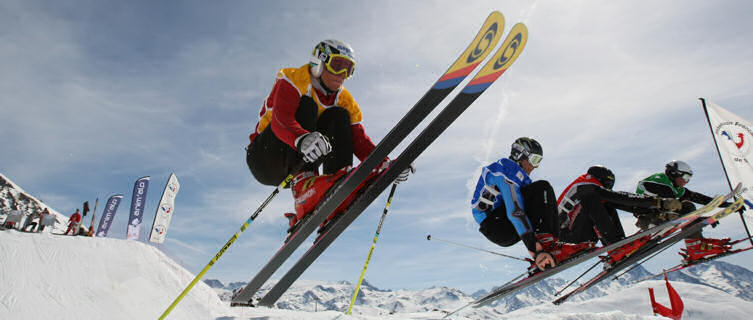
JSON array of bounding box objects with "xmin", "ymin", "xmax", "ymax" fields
[{"xmin": 636, "ymin": 160, "xmax": 745, "ymax": 261}]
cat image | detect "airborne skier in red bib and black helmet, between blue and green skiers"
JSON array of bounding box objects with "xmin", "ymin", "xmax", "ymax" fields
[{"xmin": 557, "ymin": 165, "xmax": 682, "ymax": 261}]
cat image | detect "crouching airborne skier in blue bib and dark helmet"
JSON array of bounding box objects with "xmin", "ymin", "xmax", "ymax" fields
[{"xmin": 471, "ymin": 137, "xmax": 582, "ymax": 270}]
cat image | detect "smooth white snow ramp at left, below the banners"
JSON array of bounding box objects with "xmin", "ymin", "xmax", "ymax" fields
[{"xmin": 0, "ymin": 230, "xmax": 227, "ymax": 319}]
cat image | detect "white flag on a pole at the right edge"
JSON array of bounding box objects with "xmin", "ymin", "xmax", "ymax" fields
[{"xmin": 706, "ymin": 102, "xmax": 753, "ymax": 212}]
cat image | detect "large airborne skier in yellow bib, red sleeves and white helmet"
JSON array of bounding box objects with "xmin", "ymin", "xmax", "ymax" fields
[{"xmin": 246, "ymin": 40, "xmax": 412, "ymax": 228}]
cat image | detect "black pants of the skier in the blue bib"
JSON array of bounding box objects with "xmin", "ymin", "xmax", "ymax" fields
[{"xmin": 479, "ymin": 180, "xmax": 558, "ymax": 247}]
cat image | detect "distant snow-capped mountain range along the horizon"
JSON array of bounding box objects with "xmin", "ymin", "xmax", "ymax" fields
[{"xmin": 204, "ymin": 261, "xmax": 753, "ymax": 314}]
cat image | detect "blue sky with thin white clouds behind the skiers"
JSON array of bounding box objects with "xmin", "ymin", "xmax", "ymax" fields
[{"xmin": 0, "ymin": 0, "xmax": 753, "ymax": 292}]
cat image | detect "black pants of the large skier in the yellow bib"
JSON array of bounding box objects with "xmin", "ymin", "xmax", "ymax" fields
[{"xmin": 246, "ymin": 96, "xmax": 353, "ymax": 186}]
